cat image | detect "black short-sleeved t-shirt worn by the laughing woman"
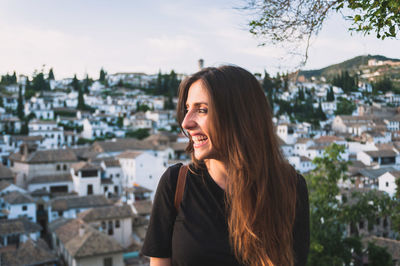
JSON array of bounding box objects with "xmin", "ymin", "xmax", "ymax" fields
[{"xmin": 142, "ymin": 164, "xmax": 310, "ymax": 266}]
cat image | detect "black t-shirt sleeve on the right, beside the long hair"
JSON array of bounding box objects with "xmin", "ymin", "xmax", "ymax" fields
[{"xmin": 293, "ymin": 175, "xmax": 310, "ymax": 266}]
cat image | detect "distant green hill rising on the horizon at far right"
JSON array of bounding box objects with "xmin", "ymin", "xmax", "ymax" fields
[{"xmin": 298, "ymin": 55, "xmax": 400, "ymax": 79}]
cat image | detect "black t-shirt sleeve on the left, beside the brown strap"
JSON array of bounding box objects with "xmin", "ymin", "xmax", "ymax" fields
[{"xmin": 142, "ymin": 164, "xmax": 181, "ymax": 258}]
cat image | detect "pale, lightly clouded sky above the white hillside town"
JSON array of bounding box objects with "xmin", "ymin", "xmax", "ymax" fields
[{"xmin": 0, "ymin": 0, "xmax": 400, "ymax": 79}]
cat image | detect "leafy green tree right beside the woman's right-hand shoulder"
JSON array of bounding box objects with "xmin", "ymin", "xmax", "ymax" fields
[{"xmin": 305, "ymin": 144, "xmax": 394, "ymax": 265}]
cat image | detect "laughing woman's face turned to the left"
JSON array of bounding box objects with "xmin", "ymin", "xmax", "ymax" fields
[{"xmin": 182, "ymin": 80, "xmax": 215, "ymax": 160}]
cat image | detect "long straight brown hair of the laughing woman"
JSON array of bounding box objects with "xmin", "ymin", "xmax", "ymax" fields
[{"xmin": 177, "ymin": 66, "xmax": 296, "ymax": 266}]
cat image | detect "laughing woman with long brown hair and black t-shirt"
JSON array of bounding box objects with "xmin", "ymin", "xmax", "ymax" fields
[{"xmin": 142, "ymin": 66, "xmax": 309, "ymax": 266}]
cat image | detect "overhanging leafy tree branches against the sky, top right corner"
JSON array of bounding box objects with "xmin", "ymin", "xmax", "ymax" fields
[{"xmin": 244, "ymin": 0, "xmax": 400, "ymax": 61}]
